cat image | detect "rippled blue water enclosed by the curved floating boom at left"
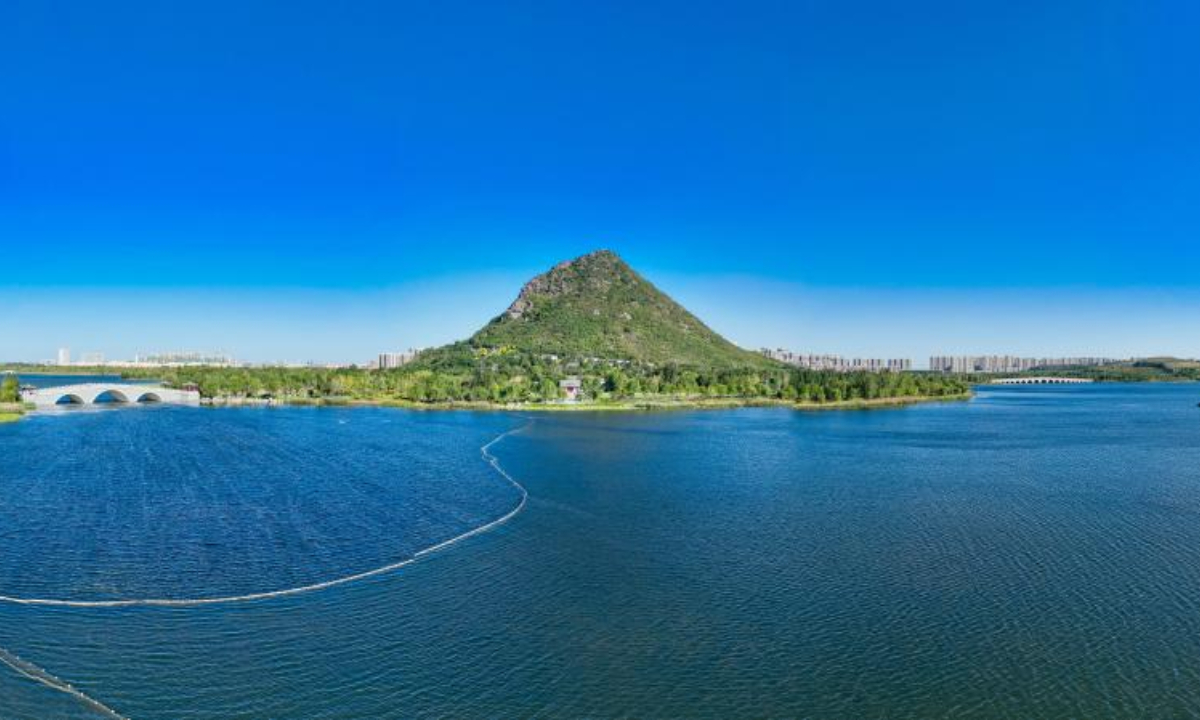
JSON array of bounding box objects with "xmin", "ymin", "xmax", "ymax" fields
[{"xmin": 0, "ymin": 408, "xmax": 515, "ymax": 601}]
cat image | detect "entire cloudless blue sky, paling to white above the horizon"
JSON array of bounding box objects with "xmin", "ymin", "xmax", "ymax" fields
[{"xmin": 0, "ymin": 0, "xmax": 1200, "ymax": 365}]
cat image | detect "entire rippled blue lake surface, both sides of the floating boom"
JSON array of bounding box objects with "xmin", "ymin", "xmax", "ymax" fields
[{"xmin": 0, "ymin": 385, "xmax": 1200, "ymax": 720}]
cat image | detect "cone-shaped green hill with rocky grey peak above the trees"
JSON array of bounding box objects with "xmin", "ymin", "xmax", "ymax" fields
[{"xmin": 468, "ymin": 250, "xmax": 774, "ymax": 367}]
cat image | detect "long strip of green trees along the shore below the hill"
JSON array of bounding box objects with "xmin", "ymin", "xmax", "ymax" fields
[{"xmin": 16, "ymin": 352, "xmax": 971, "ymax": 409}]
